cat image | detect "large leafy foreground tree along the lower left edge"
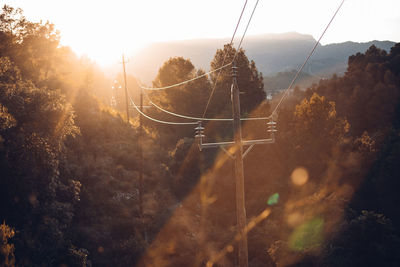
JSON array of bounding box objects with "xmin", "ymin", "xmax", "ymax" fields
[{"xmin": 0, "ymin": 58, "xmax": 84, "ymax": 265}]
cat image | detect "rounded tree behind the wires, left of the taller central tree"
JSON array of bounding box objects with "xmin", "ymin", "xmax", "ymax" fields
[{"xmin": 144, "ymin": 57, "xmax": 211, "ymax": 150}]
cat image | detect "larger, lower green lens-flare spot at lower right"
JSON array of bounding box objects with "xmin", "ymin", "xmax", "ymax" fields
[{"xmin": 289, "ymin": 217, "xmax": 324, "ymax": 251}]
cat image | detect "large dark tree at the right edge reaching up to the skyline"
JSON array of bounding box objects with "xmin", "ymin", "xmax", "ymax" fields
[{"xmin": 307, "ymin": 44, "xmax": 400, "ymax": 137}]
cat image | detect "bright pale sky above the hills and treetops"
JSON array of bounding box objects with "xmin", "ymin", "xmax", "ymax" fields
[{"xmin": 3, "ymin": 0, "xmax": 400, "ymax": 65}]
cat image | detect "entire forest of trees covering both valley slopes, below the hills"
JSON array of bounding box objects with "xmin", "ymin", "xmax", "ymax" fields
[{"xmin": 0, "ymin": 6, "xmax": 400, "ymax": 266}]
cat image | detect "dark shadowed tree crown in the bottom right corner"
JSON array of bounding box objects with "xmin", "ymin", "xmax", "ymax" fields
[{"xmin": 321, "ymin": 210, "xmax": 400, "ymax": 267}]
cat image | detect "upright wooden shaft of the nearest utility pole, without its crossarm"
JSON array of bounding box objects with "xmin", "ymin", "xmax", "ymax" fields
[{"xmin": 231, "ymin": 64, "xmax": 248, "ymax": 267}]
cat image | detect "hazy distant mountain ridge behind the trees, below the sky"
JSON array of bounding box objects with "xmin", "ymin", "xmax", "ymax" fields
[{"xmin": 132, "ymin": 32, "xmax": 395, "ymax": 83}]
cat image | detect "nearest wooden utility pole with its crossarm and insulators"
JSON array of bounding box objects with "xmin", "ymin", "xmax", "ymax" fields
[{"xmin": 195, "ymin": 64, "xmax": 276, "ymax": 267}]
